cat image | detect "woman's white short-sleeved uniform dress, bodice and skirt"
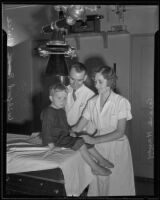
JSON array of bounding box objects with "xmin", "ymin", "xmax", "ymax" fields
[{"xmin": 84, "ymin": 92, "xmax": 135, "ymax": 196}]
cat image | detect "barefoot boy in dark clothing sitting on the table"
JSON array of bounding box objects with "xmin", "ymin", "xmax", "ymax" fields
[{"xmin": 41, "ymin": 83, "xmax": 113, "ymax": 176}]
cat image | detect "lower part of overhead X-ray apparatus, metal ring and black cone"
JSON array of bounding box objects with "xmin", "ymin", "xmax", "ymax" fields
[{"xmin": 38, "ymin": 8, "xmax": 76, "ymax": 85}]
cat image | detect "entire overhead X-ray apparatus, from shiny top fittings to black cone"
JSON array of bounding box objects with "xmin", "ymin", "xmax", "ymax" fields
[{"xmin": 38, "ymin": 5, "xmax": 100, "ymax": 82}]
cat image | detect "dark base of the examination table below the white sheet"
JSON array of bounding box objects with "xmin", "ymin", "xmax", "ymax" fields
[{"xmin": 6, "ymin": 168, "xmax": 66, "ymax": 197}]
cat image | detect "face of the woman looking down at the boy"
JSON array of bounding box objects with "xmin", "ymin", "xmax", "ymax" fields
[{"xmin": 94, "ymin": 73, "xmax": 109, "ymax": 94}]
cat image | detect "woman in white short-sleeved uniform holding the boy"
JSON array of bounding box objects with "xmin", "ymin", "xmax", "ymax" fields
[{"xmin": 73, "ymin": 66, "xmax": 135, "ymax": 196}]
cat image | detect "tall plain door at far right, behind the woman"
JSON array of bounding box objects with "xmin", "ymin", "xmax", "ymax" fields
[{"xmin": 130, "ymin": 35, "xmax": 154, "ymax": 178}]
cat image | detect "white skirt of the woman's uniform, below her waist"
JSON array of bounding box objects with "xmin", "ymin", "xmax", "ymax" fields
[{"xmin": 88, "ymin": 136, "xmax": 135, "ymax": 196}]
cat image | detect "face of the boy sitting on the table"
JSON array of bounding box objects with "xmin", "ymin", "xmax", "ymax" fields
[{"xmin": 49, "ymin": 91, "xmax": 67, "ymax": 108}]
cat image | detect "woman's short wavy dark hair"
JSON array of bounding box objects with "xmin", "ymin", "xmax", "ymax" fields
[{"xmin": 94, "ymin": 66, "xmax": 117, "ymax": 89}]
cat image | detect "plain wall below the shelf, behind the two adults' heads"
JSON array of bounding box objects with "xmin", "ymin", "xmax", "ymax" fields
[{"xmin": 67, "ymin": 34, "xmax": 130, "ymax": 98}]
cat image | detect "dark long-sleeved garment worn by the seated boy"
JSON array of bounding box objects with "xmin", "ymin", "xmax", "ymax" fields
[{"xmin": 41, "ymin": 106, "xmax": 88, "ymax": 150}]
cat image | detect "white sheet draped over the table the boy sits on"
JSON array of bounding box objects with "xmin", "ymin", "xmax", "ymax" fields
[{"xmin": 7, "ymin": 134, "xmax": 94, "ymax": 196}]
